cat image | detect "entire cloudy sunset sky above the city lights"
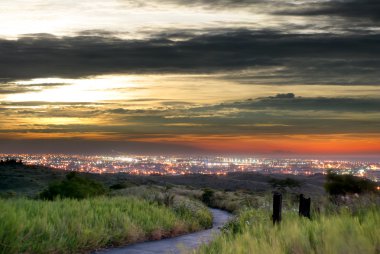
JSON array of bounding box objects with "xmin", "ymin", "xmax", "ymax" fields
[{"xmin": 0, "ymin": 0, "xmax": 380, "ymax": 157}]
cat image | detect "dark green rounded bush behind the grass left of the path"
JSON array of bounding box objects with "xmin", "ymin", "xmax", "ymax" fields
[{"xmin": 40, "ymin": 172, "xmax": 106, "ymax": 200}]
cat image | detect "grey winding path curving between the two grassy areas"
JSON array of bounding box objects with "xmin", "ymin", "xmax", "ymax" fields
[{"xmin": 95, "ymin": 209, "xmax": 232, "ymax": 254}]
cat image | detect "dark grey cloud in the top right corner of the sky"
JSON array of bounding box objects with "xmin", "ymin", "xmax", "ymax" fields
[{"xmin": 278, "ymin": 0, "xmax": 380, "ymax": 22}]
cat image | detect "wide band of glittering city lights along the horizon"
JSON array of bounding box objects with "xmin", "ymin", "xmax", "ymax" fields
[{"xmin": 0, "ymin": 154, "xmax": 380, "ymax": 182}]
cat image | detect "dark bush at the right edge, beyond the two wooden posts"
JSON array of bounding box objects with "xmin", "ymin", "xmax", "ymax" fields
[{"xmin": 325, "ymin": 171, "xmax": 376, "ymax": 195}]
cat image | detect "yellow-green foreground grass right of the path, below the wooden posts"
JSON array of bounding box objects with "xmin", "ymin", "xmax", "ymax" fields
[{"xmin": 198, "ymin": 207, "xmax": 380, "ymax": 254}]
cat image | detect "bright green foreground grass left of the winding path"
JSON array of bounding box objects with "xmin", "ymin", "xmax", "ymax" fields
[{"xmin": 0, "ymin": 197, "xmax": 211, "ymax": 254}]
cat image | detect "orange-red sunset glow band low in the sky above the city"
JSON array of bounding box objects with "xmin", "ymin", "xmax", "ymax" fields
[{"xmin": 125, "ymin": 135, "xmax": 380, "ymax": 155}]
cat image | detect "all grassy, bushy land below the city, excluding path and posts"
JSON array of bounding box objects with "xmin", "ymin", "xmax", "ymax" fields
[{"xmin": 0, "ymin": 164, "xmax": 380, "ymax": 254}]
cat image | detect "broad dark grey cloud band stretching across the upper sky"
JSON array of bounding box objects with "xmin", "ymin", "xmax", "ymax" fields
[{"xmin": 0, "ymin": 30, "xmax": 380, "ymax": 84}]
